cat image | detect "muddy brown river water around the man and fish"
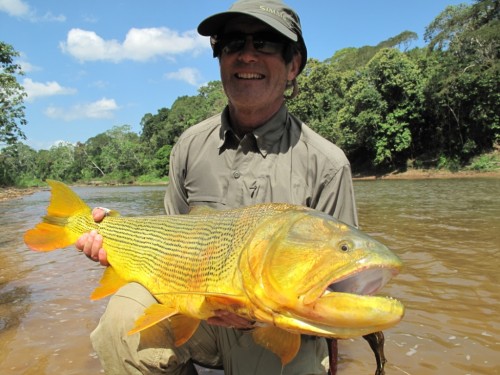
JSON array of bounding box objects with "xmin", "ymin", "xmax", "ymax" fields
[{"xmin": 0, "ymin": 178, "xmax": 500, "ymax": 375}]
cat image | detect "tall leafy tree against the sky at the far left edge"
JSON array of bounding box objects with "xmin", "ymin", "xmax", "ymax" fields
[{"xmin": 0, "ymin": 42, "xmax": 27, "ymax": 144}]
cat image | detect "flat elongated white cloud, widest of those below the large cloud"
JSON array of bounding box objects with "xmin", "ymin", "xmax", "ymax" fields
[{"xmin": 45, "ymin": 98, "xmax": 119, "ymax": 121}]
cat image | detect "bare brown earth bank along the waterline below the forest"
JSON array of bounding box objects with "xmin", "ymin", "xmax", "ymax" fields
[{"xmin": 0, "ymin": 168, "xmax": 500, "ymax": 202}]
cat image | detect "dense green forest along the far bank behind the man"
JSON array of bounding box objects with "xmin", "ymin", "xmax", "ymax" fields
[{"xmin": 0, "ymin": 0, "xmax": 500, "ymax": 186}]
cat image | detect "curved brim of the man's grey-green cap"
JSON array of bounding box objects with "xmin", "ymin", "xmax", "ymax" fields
[{"xmin": 198, "ymin": 11, "xmax": 297, "ymax": 42}]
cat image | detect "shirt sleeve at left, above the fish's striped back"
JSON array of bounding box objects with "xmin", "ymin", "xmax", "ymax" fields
[{"xmin": 163, "ymin": 144, "xmax": 189, "ymax": 215}]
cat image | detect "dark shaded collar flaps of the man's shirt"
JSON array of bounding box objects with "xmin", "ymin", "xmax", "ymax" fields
[{"xmin": 219, "ymin": 104, "xmax": 290, "ymax": 157}]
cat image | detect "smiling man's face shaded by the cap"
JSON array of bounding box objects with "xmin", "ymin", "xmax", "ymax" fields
[{"xmin": 220, "ymin": 16, "xmax": 300, "ymax": 111}]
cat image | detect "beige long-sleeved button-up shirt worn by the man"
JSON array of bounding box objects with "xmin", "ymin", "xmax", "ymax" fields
[{"xmin": 165, "ymin": 106, "xmax": 358, "ymax": 226}]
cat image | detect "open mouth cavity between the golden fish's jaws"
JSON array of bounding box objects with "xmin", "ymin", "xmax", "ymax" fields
[{"xmin": 323, "ymin": 267, "xmax": 397, "ymax": 295}]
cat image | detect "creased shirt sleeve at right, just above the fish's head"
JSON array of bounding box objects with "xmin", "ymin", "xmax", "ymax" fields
[{"xmin": 312, "ymin": 164, "xmax": 358, "ymax": 227}]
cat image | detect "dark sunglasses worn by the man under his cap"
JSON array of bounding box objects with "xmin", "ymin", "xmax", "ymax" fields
[{"xmin": 217, "ymin": 32, "xmax": 287, "ymax": 55}]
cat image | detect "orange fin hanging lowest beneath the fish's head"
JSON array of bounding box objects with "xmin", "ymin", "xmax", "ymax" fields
[{"xmin": 252, "ymin": 326, "xmax": 300, "ymax": 366}]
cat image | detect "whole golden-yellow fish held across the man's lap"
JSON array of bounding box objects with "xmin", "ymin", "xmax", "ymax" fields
[{"xmin": 24, "ymin": 181, "xmax": 404, "ymax": 365}]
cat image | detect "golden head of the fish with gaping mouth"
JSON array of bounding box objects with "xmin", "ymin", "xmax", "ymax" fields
[{"xmin": 240, "ymin": 210, "xmax": 404, "ymax": 338}]
